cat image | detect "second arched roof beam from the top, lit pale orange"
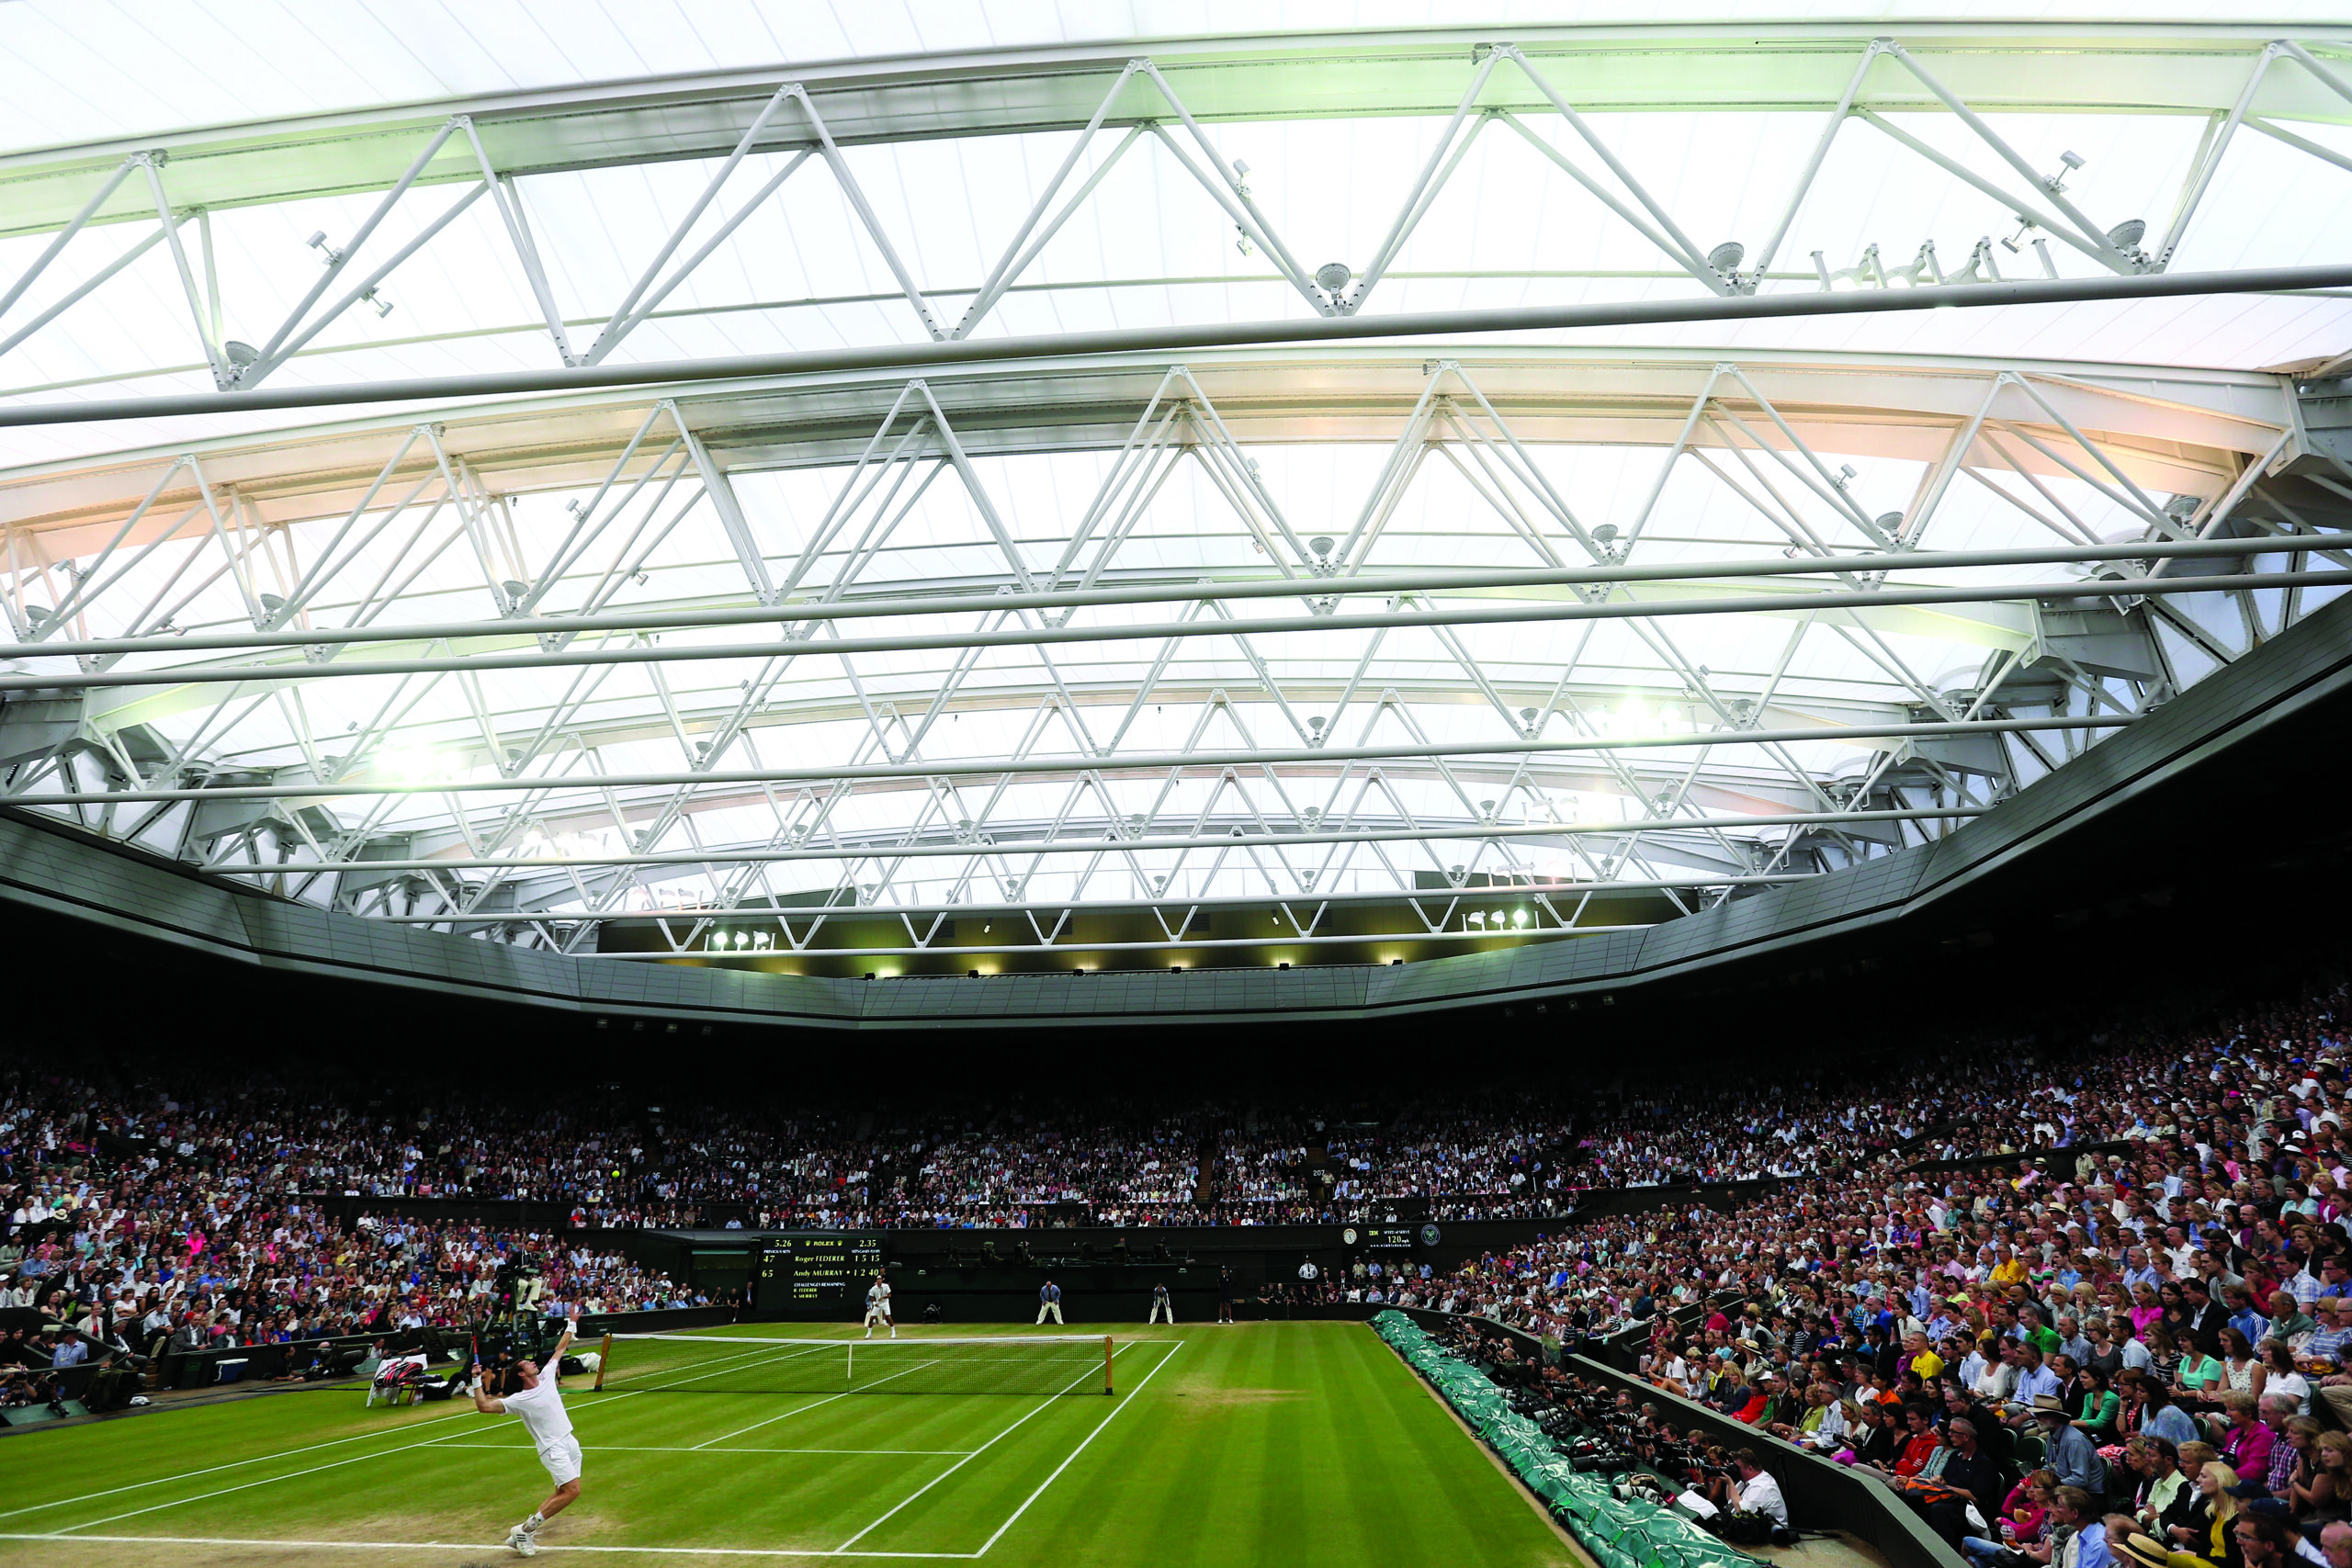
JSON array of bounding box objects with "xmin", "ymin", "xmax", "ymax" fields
[{"xmin": 0, "ymin": 345, "xmax": 2301, "ymax": 559}]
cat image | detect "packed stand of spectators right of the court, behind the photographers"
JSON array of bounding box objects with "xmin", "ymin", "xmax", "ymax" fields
[{"xmin": 1401, "ymin": 985, "xmax": 2352, "ymax": 1568}]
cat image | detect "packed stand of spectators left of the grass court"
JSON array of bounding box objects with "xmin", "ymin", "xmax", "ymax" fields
[{"xmin": 0, "ymin": 1072, "xmax": 729, "ymax": 1405}]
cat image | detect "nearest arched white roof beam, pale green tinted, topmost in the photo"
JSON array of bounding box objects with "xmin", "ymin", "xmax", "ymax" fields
[{"xmin": 0, "ymin": 21, "xmax": 2352, "ymax": 235}]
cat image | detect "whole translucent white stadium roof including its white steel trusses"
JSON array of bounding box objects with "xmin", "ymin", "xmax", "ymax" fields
[{"xmin": 0, "ymin": 18, "xmax": 2352, "ymax": 966}]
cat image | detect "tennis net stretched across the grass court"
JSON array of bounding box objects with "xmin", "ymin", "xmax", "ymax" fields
[{"xmin": 595, "ymin": 1333, "xmax": 1113, "ymax": 1394}]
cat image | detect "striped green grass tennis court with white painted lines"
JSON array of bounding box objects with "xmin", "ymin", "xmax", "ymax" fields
[{"xmin": 0, "ymin": 1324, "xmax": 1583, "ymax": 1568}]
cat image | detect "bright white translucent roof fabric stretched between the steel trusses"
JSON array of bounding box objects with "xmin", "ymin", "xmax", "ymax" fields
[{"xmin": 0, "ymin": 5, "xmax": 2352, "ymax": 959}]
